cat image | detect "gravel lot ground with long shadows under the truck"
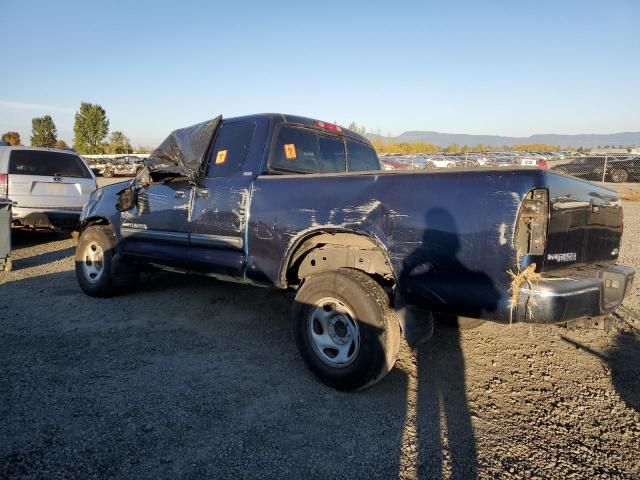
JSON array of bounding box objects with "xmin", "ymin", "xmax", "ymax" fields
[{"xmin": 0, "ymin": 189, "xmax": 640, "ymax": 479}]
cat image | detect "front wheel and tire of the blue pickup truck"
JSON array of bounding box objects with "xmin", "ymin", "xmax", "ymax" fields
[{"xmin": 75, "ymin": 225, "xmax": 139, "ymax": 297}]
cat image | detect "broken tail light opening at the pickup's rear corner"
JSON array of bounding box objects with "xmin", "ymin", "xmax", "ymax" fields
[{"xmin": 515, "ymin": 189, "xmax": 549, "ymax": 256}]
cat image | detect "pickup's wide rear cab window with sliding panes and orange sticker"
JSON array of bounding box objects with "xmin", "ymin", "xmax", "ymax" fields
[{"xmin": 269, "ymin": 125, "xmax": 380, "ymax": 174}]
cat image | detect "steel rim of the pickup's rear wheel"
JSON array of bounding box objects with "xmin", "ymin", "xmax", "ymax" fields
[{"xmin": 307, "ymin": 297, "xmax": 360, "ymax": 368}]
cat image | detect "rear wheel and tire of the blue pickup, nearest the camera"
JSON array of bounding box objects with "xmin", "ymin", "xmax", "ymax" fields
[{"xmin": 293, "ymin": 268, "xmax": 400, "ymax": 391}]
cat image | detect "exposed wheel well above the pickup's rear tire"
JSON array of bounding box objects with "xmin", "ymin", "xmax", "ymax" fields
[{"xmin": 284, "ymin": 232, "xmax": 394, "ymax": 286}]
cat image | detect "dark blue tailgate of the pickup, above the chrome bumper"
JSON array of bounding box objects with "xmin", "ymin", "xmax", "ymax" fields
[{"xmin": 544, "ymin": 174, "xmax": 622, "ymax": 270}]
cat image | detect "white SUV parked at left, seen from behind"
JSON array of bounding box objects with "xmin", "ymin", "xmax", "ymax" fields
[{"xmin": 0, "ymin": 146, "xmax": 97, "ymax": 229}]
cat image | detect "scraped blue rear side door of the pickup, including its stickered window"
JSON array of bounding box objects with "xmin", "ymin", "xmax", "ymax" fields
[{"xmin": 190, "ymin": 121, "xmax": 256, "ymax": 279}]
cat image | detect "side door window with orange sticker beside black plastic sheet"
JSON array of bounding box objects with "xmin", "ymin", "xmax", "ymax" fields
[{"xmin": 207, "ymin": 122, "xmax": 255, "ymax": 178}]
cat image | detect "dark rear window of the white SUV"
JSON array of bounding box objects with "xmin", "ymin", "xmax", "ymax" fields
[{"xmin": 9, "ymin": 150, "xmax": 93, "ymax": 178}]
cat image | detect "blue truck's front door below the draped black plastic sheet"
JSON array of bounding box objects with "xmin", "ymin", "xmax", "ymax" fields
[{"xmin": 120, "ymin": 179, "xmax": 193, "ymax": 268}]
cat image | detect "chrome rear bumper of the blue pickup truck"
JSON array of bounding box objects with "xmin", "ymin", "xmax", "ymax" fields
[{"xmin": 513, "ymin": 265, "xmax": 635, "ymax": 323}]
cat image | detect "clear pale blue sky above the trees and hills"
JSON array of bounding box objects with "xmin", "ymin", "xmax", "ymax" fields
[{"xmin": 0, "ymin": 0, "xmax": 640, "ymax": 147}]
